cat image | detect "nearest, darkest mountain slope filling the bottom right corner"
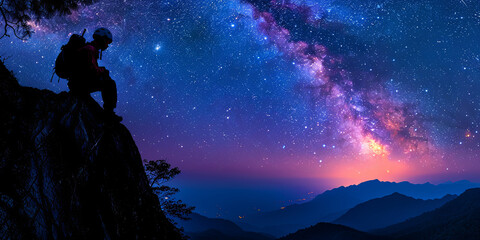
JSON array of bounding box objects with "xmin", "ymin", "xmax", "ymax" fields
[{"xmin": 279, "ymin": 188, "xmax": 480, "ymax": 240}]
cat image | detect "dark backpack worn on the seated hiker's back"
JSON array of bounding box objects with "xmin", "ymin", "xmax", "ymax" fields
[{"xmin": 50, "ymin": 29, "xmax": 86, "ymax": 82}]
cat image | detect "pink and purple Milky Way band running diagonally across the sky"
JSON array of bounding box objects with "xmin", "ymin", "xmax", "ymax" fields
[{"xmin": 244, "ymin": 1, "xmax": 429, "ymax": 159}]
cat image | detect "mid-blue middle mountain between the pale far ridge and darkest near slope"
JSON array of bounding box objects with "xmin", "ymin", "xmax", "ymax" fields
[{"xmin": 333, "ymin": 192, "xmax": 457, "ymax": 231}]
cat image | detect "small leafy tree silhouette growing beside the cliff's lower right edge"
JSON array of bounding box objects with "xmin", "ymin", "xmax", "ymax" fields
[{"xmin": 144, "ymin": 160, "xmax": 195, "ymax": 222}]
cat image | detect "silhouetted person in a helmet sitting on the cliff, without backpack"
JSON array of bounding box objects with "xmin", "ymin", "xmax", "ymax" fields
[{"xmin": 68, "ymin": 28, "xmax": 122, "ymax": 122}]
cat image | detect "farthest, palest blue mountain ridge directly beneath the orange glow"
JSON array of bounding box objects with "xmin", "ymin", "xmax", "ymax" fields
[{"xmin": 239, "ymin": 180, "xmax": 480, "ymax": 237}]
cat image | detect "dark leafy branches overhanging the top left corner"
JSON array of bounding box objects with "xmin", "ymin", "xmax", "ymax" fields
[{"xmin": 0, "ymin": 0, "xmax": 98, "ymax": 40}]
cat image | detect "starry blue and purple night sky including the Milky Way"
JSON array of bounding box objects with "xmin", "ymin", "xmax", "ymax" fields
[{"xmin": 0, "ymin": 0, "xmax": 480, "ymax": 217}]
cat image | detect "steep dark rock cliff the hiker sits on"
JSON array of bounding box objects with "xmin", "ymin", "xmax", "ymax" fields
[{"xmin": 0, "ymin": 63, "xmax": 180, "ymax": 240}]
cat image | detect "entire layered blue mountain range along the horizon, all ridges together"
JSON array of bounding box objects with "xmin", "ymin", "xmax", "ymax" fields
[{"xmin": 179, "ymin": 180, "xmax": 480, "ymax": 240}]
